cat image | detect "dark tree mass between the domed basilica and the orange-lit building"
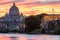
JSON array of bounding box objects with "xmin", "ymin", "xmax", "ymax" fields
[{"xmin": 25, "ymin": 14, "xmax": 46, "ymax": 32}]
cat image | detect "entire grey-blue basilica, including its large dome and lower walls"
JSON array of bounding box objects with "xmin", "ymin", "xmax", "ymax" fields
[{"xmin": 0, "ymin": 3, "xmax": 25, "ymax": 31}]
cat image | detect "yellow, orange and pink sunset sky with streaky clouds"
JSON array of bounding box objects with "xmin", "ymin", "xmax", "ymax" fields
[{"xmin": 0, "ymin": 0, "xmax": 60, "ymax": 17}]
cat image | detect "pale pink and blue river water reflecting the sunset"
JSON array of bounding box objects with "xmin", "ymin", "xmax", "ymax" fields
[{"xmin": 0, "ymin": 33, "xmax": 60, "ymax": 40}]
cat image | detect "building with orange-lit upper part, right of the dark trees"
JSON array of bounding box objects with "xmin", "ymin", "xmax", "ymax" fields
[{"xmin": 43, "ymin": 14, "xmax": 60, "ymax": 32}]
